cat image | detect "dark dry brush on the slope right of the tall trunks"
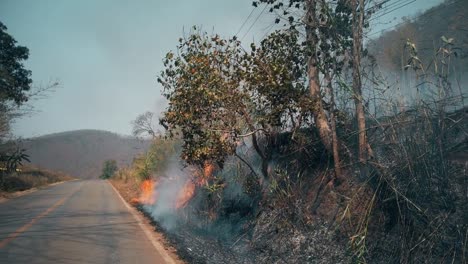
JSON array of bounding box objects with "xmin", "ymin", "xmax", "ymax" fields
[{"xmin": 351, "ymin": 38, "xmax": 468, "ymax": 263}]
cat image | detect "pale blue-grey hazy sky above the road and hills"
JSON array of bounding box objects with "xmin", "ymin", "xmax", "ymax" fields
[{"xmin": 0, "ymin": 0, "xmax": 442, "ymax": 137}]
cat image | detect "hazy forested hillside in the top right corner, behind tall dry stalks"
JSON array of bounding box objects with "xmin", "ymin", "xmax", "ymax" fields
[{"xmin": 368, "ymin": 0, "xmax": 468, "ymax": 74}]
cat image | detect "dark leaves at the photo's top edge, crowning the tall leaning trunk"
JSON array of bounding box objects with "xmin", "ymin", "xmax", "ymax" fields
[{"xmin": 253, "ymin": 0, "xmax": 352, "ymax": 73}]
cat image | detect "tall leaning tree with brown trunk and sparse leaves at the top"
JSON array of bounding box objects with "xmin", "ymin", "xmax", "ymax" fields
[{"xmin": 253, "ymin": 0, "xmax": 350, "ymax": 152}]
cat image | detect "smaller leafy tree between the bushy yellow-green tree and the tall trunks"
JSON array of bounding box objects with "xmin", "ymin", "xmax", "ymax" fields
[{"xmin": 242, "ymin": 30, "xmax": 314, "ymax": 177}]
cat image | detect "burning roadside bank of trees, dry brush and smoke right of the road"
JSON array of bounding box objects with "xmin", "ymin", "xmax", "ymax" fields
[{"xmin": 114, "ymin": 0, "xmax": 468, "ymax": 263}]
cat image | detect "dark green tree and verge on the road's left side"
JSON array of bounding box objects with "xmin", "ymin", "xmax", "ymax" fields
[{"xmin": 0, "ymin": 21, "xmax": 62, "ymax": 192}]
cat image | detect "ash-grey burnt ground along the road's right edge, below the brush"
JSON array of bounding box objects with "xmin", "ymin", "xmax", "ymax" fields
[{"xmin": 111, "ymin": 177, "xmax": 350, "ymax": 264}]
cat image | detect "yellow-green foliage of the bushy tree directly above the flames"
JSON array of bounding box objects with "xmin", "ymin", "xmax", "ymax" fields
[{"xmin": 158, "ymin": 29, "xmax": 246, "ymax": 165}]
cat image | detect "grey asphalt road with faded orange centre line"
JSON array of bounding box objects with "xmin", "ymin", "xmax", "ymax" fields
[{"xmin": 0, "ymin": 180, "xmax": 174, "ymax": 264}]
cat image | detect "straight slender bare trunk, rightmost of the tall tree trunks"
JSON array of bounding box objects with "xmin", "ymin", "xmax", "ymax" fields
[{"xmin": 351, "ymin": 0, "xmax": 368, "ymax": 173}]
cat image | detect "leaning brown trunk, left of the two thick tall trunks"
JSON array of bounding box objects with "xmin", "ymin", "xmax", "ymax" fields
[{"xmin": 305, "ymin": 0, "xmax": 332, "ymax": 152}]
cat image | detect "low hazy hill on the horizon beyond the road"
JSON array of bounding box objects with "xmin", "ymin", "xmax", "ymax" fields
[{"xmin": 22, "ymin": 130, "xmax": 149, "ymax": 179}]
